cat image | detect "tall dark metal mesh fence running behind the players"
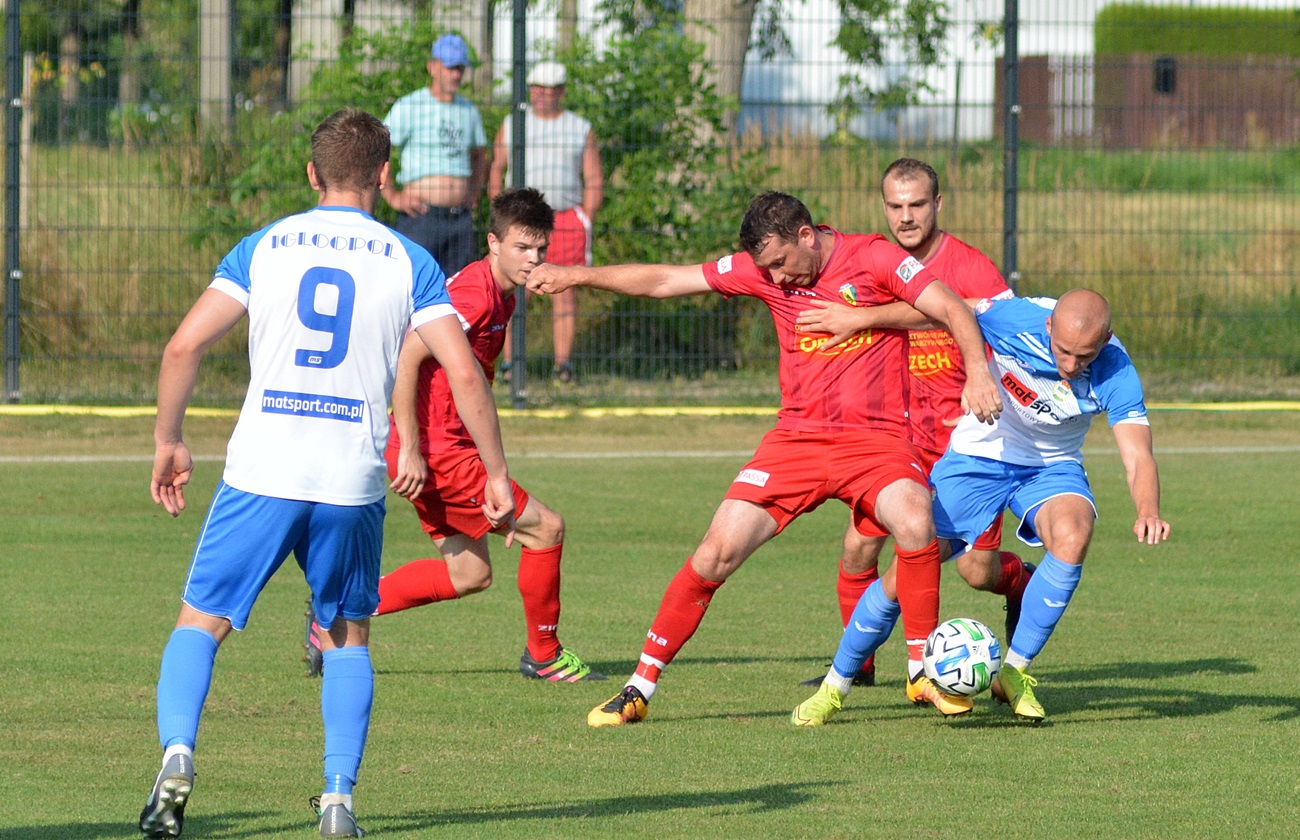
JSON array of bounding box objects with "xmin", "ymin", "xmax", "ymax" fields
[{"xmin": 5, "ymin": 0, "xmax": 1300, "ymax": 406}]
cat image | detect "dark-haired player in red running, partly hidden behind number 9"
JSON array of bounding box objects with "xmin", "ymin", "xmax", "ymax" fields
[{"xmin": 308, "ymin": 189, "xmax": 605, "ymax": 683}]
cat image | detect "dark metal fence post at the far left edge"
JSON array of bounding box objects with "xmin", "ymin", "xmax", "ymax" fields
[{"xmin": 4, "ymin": 0, "xmax": 23, "ymax": 403}]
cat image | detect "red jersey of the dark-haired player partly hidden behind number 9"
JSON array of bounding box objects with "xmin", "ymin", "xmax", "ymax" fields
[{"xmin": 403, "ymin": 257, "xmax": 515, "ymax": 455}]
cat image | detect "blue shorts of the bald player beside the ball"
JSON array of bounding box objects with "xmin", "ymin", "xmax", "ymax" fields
[{"xmin": 930, "ymin": 450, "xmax": 1097, "ymax": 554}]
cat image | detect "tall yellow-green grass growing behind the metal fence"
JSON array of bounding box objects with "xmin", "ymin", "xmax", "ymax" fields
[{"xmin": 12, "ymin": 135, "xmax": 1300, "ymax": 404}]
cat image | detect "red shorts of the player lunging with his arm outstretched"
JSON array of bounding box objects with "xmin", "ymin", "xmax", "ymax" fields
[{"xmin": 727, "ymin": 429, "xmax": 926, "ymax": 533}]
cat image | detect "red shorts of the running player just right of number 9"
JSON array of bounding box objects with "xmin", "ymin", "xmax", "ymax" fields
[{"xmin": 384, "ymin": 444, "xmax": 528, "ymax": 540}]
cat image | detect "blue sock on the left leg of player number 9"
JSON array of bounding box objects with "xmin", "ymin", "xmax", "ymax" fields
[{"xmin": 159, "ymin": 627, "xmax": 217, "ymax": 750}]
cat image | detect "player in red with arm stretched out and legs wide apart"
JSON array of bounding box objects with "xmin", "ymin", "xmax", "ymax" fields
[{"xmin": 528, "ymin": 192, "xmax": 1001, "ymax": 726}]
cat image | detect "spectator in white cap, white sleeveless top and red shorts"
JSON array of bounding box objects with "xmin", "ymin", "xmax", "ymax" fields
[{"xmin": 488, "ymin": 61, "xmax": 605, "ymax": 382}]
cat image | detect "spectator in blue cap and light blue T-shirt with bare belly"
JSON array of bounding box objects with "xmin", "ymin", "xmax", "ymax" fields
[{"xmin": 384, "ymin": 34, "xmax": 488, "ymax": 277}]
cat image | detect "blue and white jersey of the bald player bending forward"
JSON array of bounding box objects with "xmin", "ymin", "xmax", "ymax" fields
[{"xmin": 949, "ymin": 298, "xmax": 1149, "ymax": 466}]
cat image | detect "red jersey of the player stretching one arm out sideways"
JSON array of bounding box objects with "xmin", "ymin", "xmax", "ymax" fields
[{"xmin": 703, "ymin": 226, "xmax": 935, "ymax": 437}]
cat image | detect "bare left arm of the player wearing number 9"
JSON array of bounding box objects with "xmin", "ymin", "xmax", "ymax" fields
[{"xmin": 150, "ymin": 289, "xmax": 246, "ymax": 516}]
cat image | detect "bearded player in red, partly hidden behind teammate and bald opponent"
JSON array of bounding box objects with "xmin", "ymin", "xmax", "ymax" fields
[{"xmin": 798, "ymin": 157, "xmax": 1034, "ymax": 685}]
